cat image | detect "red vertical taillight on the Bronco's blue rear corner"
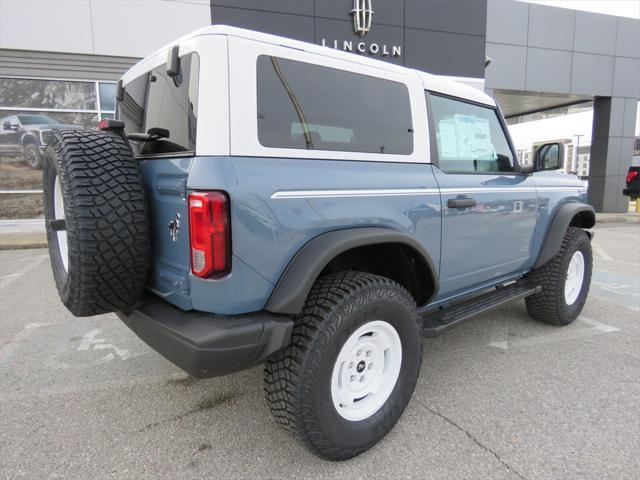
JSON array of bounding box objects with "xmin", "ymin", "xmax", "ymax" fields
[{"xmin": 189, "ymin": 192, "xmax": 231, "ymax": 278}]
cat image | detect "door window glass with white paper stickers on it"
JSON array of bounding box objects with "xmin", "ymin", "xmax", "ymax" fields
[{"xmin": 429, "ymin": 94, "xmax": 514, "ymax": 173}]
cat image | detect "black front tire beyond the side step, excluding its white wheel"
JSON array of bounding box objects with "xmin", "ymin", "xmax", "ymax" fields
[{"xmin": 525, "ymin": 227, "xmax": 593, "ymax": 326}]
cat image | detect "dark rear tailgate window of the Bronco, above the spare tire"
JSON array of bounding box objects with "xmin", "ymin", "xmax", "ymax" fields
[{"xmin": 118, "ymin": 53, "xmax": 200, "ymax": 155}]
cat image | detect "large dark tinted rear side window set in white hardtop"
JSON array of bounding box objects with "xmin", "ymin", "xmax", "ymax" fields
[{"xmin": 257, "ymin": 55, "xmax": 413, "ymax": 155}]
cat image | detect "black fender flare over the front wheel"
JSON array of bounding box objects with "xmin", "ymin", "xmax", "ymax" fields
[{"xmin": 533, "ymin": 202, "xmax": 596, "ymax": 268}]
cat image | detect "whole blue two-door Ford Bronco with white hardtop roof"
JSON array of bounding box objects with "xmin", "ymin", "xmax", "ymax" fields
[{"xmin": 44, "ymin": 26, "xmax": 595, "ymax": 460}]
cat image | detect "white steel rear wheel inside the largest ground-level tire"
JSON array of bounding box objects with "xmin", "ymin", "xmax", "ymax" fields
[{"xmin": 331, "ymin": 320, "xmax": 402, "ymax": 422}]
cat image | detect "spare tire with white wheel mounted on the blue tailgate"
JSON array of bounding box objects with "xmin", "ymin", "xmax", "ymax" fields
[{"xmin": 43, "ymin": 130, "xmax": 150, "ymax": 317}]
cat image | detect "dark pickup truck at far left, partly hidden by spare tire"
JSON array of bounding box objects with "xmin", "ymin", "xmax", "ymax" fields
[{"xmin": 0, "ymin": 114, "xmax": 81, "ymax": 169}]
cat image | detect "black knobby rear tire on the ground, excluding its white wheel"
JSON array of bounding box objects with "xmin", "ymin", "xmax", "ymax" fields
[{"xmin": 264, "ymin": 271, "xmax": 422, "ymax": 460}]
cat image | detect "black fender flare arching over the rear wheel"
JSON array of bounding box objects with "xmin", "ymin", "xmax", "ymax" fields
[{"xmin": 265, "ymin": 227, "xmax": 438, "ymax": 314}]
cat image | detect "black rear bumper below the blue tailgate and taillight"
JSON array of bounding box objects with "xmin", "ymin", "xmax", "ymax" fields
[{"xmin": 117, "ymin": 295, "xmax": 293, "ymax": 378}]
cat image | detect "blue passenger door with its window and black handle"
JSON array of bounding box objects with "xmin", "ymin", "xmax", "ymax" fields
[{"xmin": 427, "ymin": 93, "xmax": 537, "ymax": 300}]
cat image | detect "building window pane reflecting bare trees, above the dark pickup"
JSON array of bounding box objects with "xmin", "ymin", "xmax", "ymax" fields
[{"xmin": 0, "ymin": 78, "xmax": 97, "ymax": 110}]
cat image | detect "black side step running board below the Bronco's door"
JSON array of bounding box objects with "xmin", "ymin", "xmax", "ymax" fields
[{"xmin": 422, "ymin": 280, "xmax": 542, "ymax": 337}]
